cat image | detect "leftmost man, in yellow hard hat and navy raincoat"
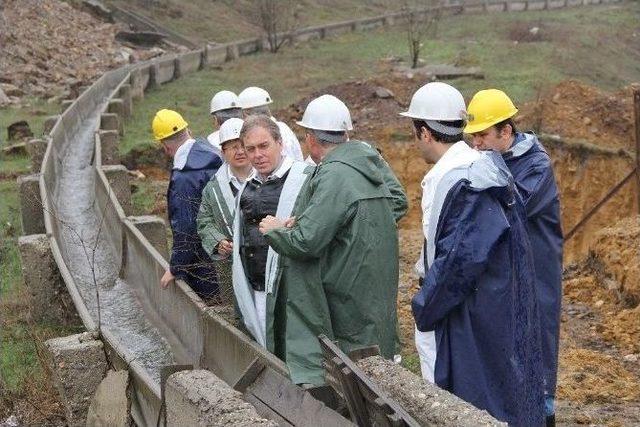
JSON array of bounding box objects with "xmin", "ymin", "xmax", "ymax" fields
[{"xmin": 151, "ymin": 109, "xmax": 222, "ymax": 300}]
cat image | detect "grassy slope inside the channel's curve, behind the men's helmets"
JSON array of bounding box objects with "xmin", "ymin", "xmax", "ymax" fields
[{"xmin": 121, "ymin": 2, "xmax": 640, "ymax": 153}]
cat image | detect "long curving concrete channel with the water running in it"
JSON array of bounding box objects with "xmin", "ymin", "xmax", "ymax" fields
[{"xmin": 33, "ymin": 2, "xmax": 608, "ymax": 426}]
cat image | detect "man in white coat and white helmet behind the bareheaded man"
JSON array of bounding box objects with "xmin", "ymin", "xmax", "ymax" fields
[{"xmin": 238, "ymin": 86, "xmax": 303, "ymax": 161}]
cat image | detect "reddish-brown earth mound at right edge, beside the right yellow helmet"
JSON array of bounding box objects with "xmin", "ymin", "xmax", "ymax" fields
[{"xmin": 518, "ymin": 80, "xmax": 634, "ymax": 149}]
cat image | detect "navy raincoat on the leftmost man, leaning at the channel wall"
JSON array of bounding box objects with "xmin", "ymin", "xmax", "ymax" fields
[{"xmin": 167, "ymin": 139, "xmax": 222, "ymax": 298}]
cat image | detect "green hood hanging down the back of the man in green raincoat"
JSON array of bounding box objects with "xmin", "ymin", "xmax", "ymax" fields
[{"xmin": 322, "ymin": 140, "xmax": 384, "ymax": 186}]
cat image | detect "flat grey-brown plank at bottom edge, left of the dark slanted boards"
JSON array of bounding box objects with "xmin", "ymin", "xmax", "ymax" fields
[{"xmin": 244, "ymin": 367, "xmax": 353, "ymax": 427}]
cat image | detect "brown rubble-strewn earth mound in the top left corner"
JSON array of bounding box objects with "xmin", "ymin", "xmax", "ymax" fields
[{"xmin": 0, "ymin": 0, "xmax": 165, "ymax": 98}]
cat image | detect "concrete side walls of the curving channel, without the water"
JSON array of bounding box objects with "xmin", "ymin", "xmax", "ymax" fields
[{"xmin": 31, "ymin": 0, "xmax": 620, "ymax": 426}]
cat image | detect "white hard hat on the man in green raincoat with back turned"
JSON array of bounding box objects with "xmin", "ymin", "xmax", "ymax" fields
[{"xmin": 296, "ymin": 95, "xmax": 353, "ymax": 132}]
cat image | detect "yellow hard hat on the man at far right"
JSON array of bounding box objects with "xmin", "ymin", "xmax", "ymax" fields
[{"xmin": 464, "ymin": 89, "xmax": 518, "ymax": 133}]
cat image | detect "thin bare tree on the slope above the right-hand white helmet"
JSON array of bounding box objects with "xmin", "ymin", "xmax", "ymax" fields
[{"xmin": 402, "ymin": 0, "xmax": 442, "ymax": 68}]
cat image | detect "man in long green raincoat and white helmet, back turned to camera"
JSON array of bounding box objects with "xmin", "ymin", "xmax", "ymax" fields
[{"xmin": 260, "ymin": 95, "xmax": 407, "ymax": 385}]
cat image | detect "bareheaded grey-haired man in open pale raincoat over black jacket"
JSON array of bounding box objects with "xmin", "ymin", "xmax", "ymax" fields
[{"xmin": 232, "ymin": 115, "xmax": 313, "ymax": 352}]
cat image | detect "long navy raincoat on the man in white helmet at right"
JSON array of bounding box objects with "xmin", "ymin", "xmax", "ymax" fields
[{"xmin": 412, "ymin": 153, "xmax": 544, "ymax": 426}]
